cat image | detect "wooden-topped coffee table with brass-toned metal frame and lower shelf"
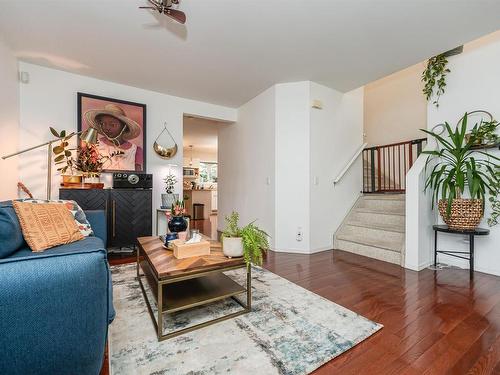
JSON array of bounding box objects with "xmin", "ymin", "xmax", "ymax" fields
[{"xmin": 137, "ymin": 236, "xmax": 252, "ymax": 341}]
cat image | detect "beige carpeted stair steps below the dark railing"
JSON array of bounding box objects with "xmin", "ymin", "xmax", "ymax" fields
[{"xmin": 334, "ymin": 194, "xmax": 405, "ymax": 265}]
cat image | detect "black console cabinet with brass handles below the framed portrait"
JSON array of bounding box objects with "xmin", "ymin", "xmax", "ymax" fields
[{"xmin": 59, "ymin": 188, "xmax": 153, "ymax": 247}]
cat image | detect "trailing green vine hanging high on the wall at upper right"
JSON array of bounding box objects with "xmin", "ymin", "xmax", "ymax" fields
[{"xmin": 422, "ymin": 46, "xmax": 463, "ymax": 108}]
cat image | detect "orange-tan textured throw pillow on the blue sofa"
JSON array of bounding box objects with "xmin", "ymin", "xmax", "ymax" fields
[{"xmin": 12, "ymin": 201, "xmax": 84, "ymax": 252}]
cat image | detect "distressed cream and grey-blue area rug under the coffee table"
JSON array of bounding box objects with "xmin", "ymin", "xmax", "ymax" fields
[{"xmin": 109, "ymin": 265, "xmax": 382, "ymax": 375}]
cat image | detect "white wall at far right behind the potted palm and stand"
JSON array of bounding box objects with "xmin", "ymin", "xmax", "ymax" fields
[{"xmin": 406, "ymin": 32, "xmax": 500, "ymax": 275}]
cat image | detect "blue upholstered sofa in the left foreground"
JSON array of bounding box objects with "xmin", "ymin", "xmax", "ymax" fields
[{"xmin": 0, "ymin": 202, "xmax": 115, "ymax": 375}]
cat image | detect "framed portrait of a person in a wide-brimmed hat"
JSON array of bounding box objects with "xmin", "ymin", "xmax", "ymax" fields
[{"xmin": 78, "ymin": 92, "xmax": 146, "ymax": 172}]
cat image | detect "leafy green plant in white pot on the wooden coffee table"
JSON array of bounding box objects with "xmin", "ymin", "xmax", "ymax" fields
[{"xmin": 222, "ymin": 211, "xmax": 269, "ymax": 266}]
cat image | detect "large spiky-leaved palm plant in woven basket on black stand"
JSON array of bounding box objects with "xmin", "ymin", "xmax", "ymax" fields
[{"xmin": 422, "ymin": 113, "xmax": 500, "ymax": 230}]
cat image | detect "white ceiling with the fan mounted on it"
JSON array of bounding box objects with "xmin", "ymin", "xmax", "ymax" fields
[{"xmin": 0, "ymin": 0, "xmax": 500, "ymax": 107}]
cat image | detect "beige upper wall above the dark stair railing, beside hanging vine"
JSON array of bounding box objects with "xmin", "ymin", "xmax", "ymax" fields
[{"xmin": 364, "ymin": 63, "xmax": 427, "ymax": 146}]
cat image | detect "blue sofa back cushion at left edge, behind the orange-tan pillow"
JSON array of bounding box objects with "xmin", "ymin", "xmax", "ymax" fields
[{"xmin": 0, "ymin": 202, "xmax": 26, "ymax": 259}]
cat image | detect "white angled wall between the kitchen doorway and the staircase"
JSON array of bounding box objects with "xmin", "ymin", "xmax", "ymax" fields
[{"xmin": 218, "ymin": 81, "xmax": 363, "ymax": 253}]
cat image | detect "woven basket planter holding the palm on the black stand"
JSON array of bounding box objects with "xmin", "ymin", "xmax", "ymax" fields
[{"xmin": 438, "ymin": 198, "xmax": 483, "ymax": 230}]
